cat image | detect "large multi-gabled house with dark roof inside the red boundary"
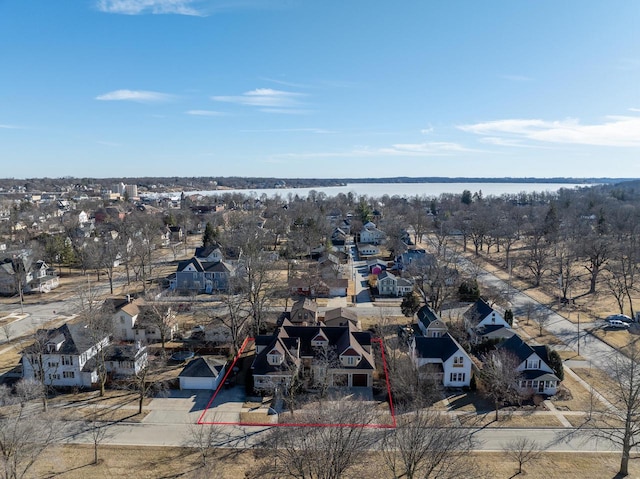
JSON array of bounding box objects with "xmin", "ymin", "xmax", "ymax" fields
[{"xmin": 251, "ymin": 324, "xmax": 375, "ymax": 391}]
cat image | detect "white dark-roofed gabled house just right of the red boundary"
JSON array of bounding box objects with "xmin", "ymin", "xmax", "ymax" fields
[{"xmin": 410, "ymin": 333, "xmax": 472, "ymax": 387}]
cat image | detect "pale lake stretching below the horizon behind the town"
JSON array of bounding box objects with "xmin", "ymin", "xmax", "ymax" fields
[{"xmin": 185, "ymin": 183, "xmax": 590, "ymax": 198}]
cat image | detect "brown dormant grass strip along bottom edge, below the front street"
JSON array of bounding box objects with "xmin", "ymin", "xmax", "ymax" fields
[{"xmin": 29, "ymin": 446, "xmax": 640, "ymax": 479}]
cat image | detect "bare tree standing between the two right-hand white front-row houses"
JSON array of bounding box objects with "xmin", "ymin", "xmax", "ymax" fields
[{"xmin": 479, "ymin": 349, "xmax": 522, "ymax": 421}]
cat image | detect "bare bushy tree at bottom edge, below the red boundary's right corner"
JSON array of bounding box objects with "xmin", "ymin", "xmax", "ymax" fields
[{"xmin": 380, "ymin": 409, "xmax": 480, "ymax": 479}]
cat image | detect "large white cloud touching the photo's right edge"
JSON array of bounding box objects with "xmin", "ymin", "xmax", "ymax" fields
[{"xmin": 458, "ymin": 116, "xmax": 640, "ymax": 147}]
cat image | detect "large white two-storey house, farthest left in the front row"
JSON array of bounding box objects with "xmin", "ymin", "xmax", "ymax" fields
[{"xmin": 22, "ymin": 323, "xmax": 110, "ymax": 387}]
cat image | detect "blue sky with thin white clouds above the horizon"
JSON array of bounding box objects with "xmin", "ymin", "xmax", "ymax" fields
[{"xmin": 0, "ymin": 0, "xmax": 640, "ymax": 178}]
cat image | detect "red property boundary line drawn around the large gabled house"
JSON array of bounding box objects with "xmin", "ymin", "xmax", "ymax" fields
[{"xmin": 197, "ymin": 338, "xmax": 397, "ymax": 429}]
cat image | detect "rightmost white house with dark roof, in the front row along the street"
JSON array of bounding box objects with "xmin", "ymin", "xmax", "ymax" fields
[{"xmin": 497, "ymin": 334, "xmax": 560, "ymax": 396}]
